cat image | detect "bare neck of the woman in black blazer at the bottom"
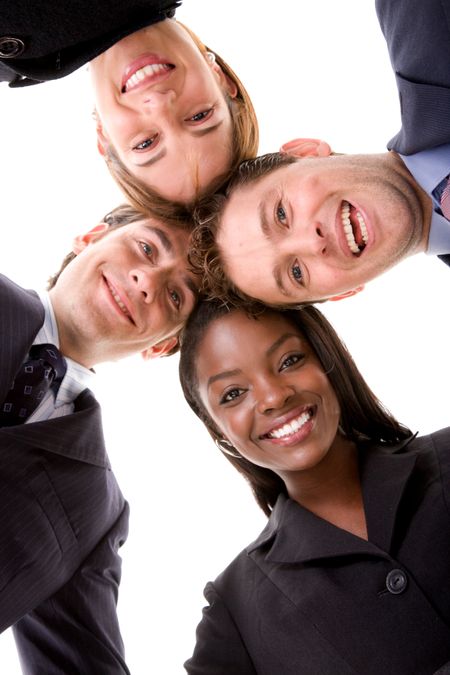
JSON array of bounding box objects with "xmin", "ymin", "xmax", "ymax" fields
[{"xmin": 283, "ymin": 436, "xmax": 367, "ymax": 539}]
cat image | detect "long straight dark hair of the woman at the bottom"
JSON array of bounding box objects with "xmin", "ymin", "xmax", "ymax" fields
[{"xmin": 179, "ymin": 300, "xmax": 411, "ymax": 515}]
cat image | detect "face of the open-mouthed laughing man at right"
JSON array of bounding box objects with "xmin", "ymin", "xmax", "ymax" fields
[{"xmin": 217, "ymin": 153, "xmax": 428, "ymax": 304}]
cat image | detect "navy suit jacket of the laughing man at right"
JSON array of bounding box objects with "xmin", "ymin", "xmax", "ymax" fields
[{"xmin": 376, "ymin": 0, "xmax": 450, "ymax": 266}]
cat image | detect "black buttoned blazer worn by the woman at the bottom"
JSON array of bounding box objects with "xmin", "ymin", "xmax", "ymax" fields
[{"xmin": 185, "ymin": 429, "xmax": 450, "ymax": 675}]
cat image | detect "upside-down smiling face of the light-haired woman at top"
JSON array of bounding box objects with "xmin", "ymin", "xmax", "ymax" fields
[{"xmin": 90, "ymin": 19, "xmax": 236, "ymax": 201}]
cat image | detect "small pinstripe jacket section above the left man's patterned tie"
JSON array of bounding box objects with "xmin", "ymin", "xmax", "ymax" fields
[{"xmin": 0, "ymin": 275, "xmax": 45, "ymax": 403}]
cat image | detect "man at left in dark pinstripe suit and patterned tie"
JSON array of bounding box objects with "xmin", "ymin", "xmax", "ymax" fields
[{"xmin": 0, "ymin": 207, "xmax": 197, "ymax": 675}]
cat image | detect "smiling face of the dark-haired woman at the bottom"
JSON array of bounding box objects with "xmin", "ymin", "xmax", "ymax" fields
[{"xmin": 197, "ymin": 311, "xmax": 340, "ymax": 483}]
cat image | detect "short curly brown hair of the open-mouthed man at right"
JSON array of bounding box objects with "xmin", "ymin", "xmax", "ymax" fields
[{"xmin": 189, "ymin": 152, "xmax": 298, "ymax": 311}]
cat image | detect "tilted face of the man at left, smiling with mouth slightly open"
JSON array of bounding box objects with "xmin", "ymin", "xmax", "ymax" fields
[{"xmin": 50, "ymin": 220, "xmax": 197, "ymax": 366}]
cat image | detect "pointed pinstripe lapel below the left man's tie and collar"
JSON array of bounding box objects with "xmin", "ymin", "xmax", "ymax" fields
[{"xmin": 0, "ymin": 389, "xmax": 110, "ymax": 469}]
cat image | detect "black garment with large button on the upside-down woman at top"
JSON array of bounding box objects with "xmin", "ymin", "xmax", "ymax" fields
[{"xmin": 0, "ymin": 0, "xmax": 181, "ymax": 86}]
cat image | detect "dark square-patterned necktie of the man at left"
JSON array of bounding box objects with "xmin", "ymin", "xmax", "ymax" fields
[{"xmin": 0, "ymin": 344, "xmax": 67, "ymax": 427}]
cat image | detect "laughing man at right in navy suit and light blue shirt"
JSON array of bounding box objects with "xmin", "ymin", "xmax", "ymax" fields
[{"xmin": 194, "ymin": 0, "xmax": 450, "ymax": 305}]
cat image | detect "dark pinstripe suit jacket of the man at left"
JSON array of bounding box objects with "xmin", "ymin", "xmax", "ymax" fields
[{"xmin": 0, "ymin": 276, "xmax": 129, "ymax": 675}]
